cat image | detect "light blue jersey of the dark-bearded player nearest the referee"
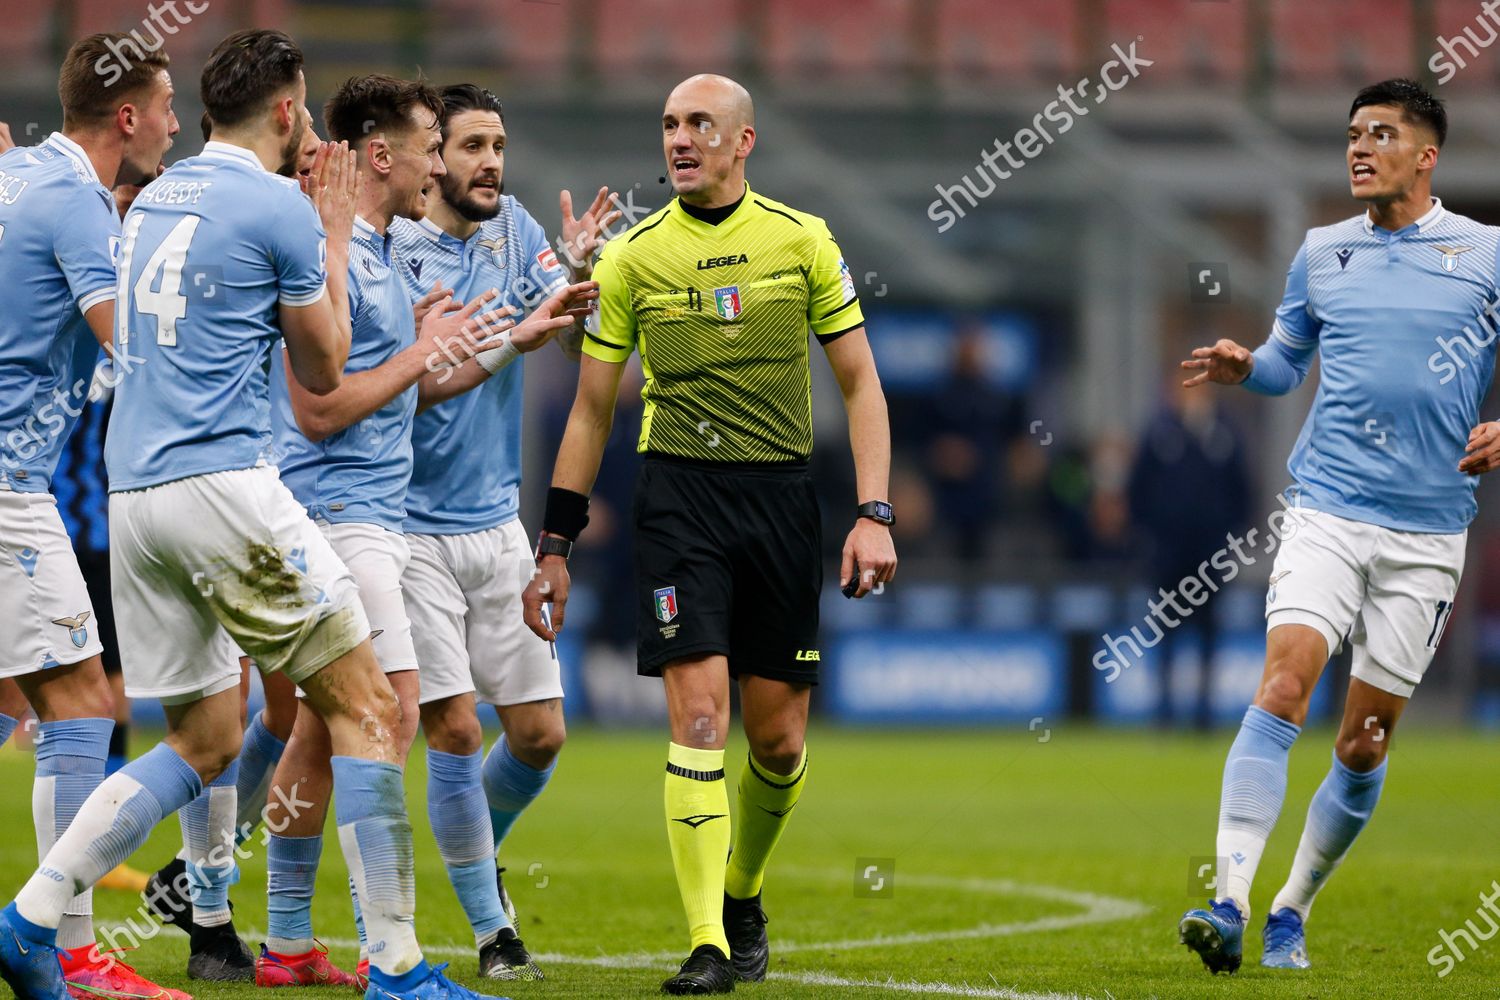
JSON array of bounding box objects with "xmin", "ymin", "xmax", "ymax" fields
[{"xmin": 392, "ymin": 195, "xmax": 566, "ymax": 535}]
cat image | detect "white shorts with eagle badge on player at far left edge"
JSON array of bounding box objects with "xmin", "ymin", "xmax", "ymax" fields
[{"xmin": 0, "ymin": 486, "xmax": 104, "ymax": 678}]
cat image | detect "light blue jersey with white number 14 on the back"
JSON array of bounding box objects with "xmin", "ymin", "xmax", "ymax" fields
[{"xmin": 105, "ymin": 142, "xmax": 327, "ymax": 492}]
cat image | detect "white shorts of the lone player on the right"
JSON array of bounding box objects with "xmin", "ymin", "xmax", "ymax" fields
[{"xmin": 1266, "ymin": 507, "xmax": 1467, "ymax": 699}]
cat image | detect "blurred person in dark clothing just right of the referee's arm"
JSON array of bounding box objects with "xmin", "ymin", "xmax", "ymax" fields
[{"xmin": 921, "ymin": 324, "xmax": 1026, "ymax": 562}]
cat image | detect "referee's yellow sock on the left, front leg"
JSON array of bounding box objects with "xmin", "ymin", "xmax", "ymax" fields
[{"xmin": 666, "ymin": 744, "xmax": 729, "ymax": 958}]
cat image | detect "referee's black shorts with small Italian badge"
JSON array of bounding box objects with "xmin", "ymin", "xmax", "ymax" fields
[{"xmin": 635, "ymin": 454, "xmax": 824, "ymax": 684}]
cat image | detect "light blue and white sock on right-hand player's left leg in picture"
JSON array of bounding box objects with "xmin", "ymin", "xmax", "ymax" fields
[{"xmin": 1218, "ymin": 705, "xmax": 1302, "ymax": 919}]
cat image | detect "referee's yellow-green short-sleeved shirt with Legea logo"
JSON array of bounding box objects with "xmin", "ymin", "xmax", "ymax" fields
[{"xmin": 584, "ymin": 186, "xmax": 864, "ymax": 462}]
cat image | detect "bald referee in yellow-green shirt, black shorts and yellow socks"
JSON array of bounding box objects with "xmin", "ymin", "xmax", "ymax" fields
[{"xmin": 524, "ymin": 75, "xmax": 896, "ymax": 994}]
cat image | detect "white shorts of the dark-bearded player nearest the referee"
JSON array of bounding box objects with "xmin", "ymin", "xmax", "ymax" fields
[{"xmin": 401, "ymin": 519, "xmax": 563, "ymax": 705}]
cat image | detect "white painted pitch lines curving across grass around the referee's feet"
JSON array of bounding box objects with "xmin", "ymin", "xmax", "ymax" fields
[{"xmin": 222, "ymin": 868, "xmax": 1151, "ymax": 1000}]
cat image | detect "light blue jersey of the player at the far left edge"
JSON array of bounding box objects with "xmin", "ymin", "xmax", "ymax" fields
[{"xmin": 0, "ymin": 132, "xmax": 120, "ymax": 493}]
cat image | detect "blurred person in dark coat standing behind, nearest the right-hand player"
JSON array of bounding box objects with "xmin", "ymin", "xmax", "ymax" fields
[{"xmin": 1128, "ymin": 370, "xmax": 1251, "ymax": 729}]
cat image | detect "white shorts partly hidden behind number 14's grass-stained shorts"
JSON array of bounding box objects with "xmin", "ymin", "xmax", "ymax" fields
[{"xmin": 297, "ymin": 517, "xmax": 417, "ymax": 697}]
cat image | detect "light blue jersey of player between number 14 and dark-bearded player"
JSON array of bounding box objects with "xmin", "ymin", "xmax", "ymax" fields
[{"xmin": 272, "ymin": 219, "xmax": 417, "ymax": 532}]
